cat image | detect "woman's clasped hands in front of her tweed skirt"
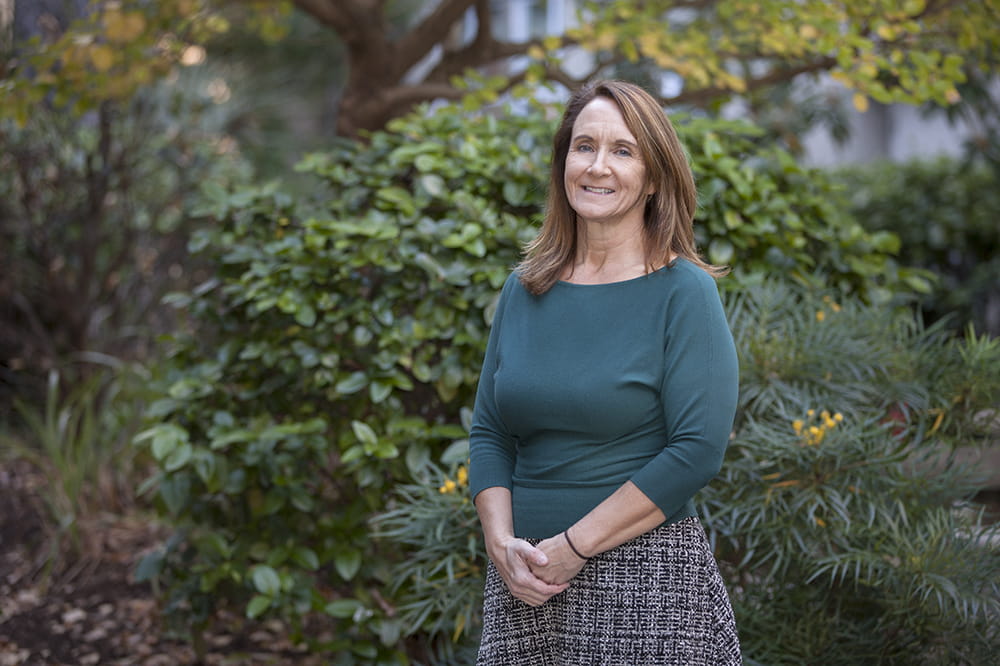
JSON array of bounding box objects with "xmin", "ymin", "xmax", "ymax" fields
[{"xmin": 490, "ymin": 535, "xmax": 585, "ymax": 606}]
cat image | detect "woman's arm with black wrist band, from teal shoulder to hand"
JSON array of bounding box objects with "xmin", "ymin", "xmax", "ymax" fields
[{"xmin": 533, "ymin": 275, "xmax": 738, "ymax": 582}]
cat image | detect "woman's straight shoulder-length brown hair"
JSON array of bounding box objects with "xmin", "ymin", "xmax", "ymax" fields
[{"xmin": 517, "ymin": 81, "xmax": 728, "ymax": 294}]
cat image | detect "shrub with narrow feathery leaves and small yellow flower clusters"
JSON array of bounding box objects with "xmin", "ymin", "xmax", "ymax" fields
[{"xmin": 377, "ymin": 283, "xmax": 1000, "ymax": 666}]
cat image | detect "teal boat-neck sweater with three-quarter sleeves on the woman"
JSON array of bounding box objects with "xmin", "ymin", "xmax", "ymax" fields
[{"xmin": 469, "ymin": 259, "xmax": 738, "ymax": 538}]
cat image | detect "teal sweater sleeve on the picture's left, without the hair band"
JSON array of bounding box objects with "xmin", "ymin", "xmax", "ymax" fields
[{"xmin": 469, "ymin": 275, "xmax": 517, "ymax": 500}]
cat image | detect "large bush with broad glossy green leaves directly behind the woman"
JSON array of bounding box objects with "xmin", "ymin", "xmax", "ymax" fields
[{"xmin": 140, "ymin": 97, "xmax": 928, "ymax": 663}]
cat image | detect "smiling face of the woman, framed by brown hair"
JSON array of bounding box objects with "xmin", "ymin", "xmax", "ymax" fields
[{"xmin": 563, "ymin": 97, "xmax": 653, "ymax": 224}]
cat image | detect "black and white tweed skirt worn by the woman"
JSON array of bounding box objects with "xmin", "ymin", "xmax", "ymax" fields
[{"xmin": 476, "ymin": 518, "xmax": 742, "ymax": 666}]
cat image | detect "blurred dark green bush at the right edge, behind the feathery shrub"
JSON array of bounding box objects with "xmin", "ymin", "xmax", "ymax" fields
[{"xmin": 838, "ymin": 158, "xmax": 1000, "ymax": 336}]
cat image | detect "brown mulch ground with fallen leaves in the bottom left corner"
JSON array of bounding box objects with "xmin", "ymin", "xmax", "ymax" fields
[{"xmin": 0, "ymin": 462, "xmax": 323, "ymax": 666}]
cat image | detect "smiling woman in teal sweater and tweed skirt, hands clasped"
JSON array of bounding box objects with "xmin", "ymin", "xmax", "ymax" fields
[{"xmin": 470, "ymin": 81, "xmax": 740, "ymax": 666}]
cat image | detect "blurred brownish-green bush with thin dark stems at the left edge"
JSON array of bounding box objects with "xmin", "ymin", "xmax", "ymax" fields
[{"xmin": 0, "ymin": 83, "xmax": 245, "ymax": 408}]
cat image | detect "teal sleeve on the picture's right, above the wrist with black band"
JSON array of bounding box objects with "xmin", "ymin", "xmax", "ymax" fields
[{"xmin": 631, "ymin": 274, "xmax": 739, "ymax": 521}]
